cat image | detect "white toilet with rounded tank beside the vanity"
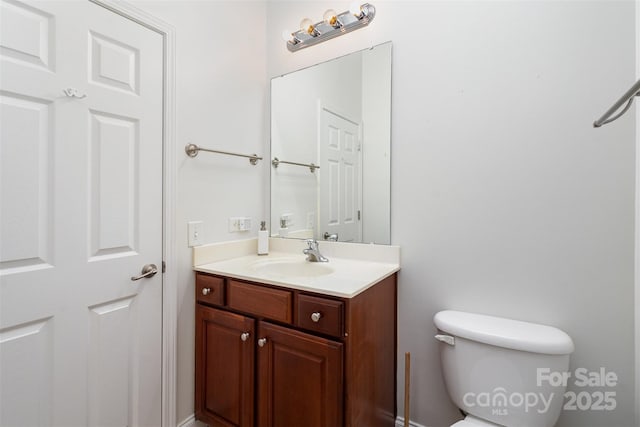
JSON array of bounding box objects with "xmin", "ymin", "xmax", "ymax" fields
[{"xmin": 433, "ymin": 310, "xmax": 574, "ymax": 427}]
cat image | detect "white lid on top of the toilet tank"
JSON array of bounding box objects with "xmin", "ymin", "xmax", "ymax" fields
[{"xmin": 433, "ymin": 310, "xmax": 574, "ymax": 354}]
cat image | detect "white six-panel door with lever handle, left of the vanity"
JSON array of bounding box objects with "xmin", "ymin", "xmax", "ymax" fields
[{"xmin": 0, "ymin": 0, "xmax": 163, "ymax": 427}]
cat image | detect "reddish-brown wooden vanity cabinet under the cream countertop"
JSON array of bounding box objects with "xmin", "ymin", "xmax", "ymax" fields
[{"xmin": 195, "ymin": 272, "xmax": 396, "ymax": 427}]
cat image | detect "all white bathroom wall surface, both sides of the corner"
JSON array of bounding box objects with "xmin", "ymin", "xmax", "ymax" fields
[{"xmin": 134, "ymin": 0, "xmax": 636, "ymax": 427}]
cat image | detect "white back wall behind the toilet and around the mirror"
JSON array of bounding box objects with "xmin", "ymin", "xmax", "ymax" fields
[{"xmin": 267, "ymin": 1, "xmax": 636, "ymax": 427}]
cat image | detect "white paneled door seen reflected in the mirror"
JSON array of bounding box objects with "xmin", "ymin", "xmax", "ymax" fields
[{"xmin": 318, "ymin": 107, "xmax": 362, "ymax": 242}]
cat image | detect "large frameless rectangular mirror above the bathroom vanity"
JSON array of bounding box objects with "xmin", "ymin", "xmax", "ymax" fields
[{"xmin": 270, "ymin": 42, "xmax": 391, "ymax": 244}]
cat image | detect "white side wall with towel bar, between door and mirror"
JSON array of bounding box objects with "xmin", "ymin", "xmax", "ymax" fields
[{"xmin": 132, "ymin": 0, "xmax": 270, "ymax": 423}]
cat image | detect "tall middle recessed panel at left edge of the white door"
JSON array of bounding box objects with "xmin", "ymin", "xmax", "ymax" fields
[{"xmin": 0, "ymin": 91, "xmax": 53, "ymax": 272}]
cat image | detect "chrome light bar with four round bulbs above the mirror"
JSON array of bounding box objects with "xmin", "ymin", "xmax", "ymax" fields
[{"xmin": 282, "ymin": 3, "xmax": 376, "ymax": 52}]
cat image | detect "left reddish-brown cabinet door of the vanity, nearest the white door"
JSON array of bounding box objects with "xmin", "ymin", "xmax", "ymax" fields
[{"xmin": 195, "ymin": 304, "xmax": 255, "ymax": 427}]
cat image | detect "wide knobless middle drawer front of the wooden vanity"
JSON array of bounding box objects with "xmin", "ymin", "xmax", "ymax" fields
[{"xmin": 227, "ymin": 280, "xmax": 292, "ymax": 323}]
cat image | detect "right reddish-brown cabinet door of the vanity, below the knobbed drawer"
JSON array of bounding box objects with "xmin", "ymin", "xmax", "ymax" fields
[{"xmin": 257, "ymin": 322, "xmax": 343, "ymax": 427}]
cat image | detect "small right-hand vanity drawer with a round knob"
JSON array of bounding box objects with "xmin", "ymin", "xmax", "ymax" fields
[{"xmin": 296, "ymin": 294, "xmax": 344, "ymax": 337}]
